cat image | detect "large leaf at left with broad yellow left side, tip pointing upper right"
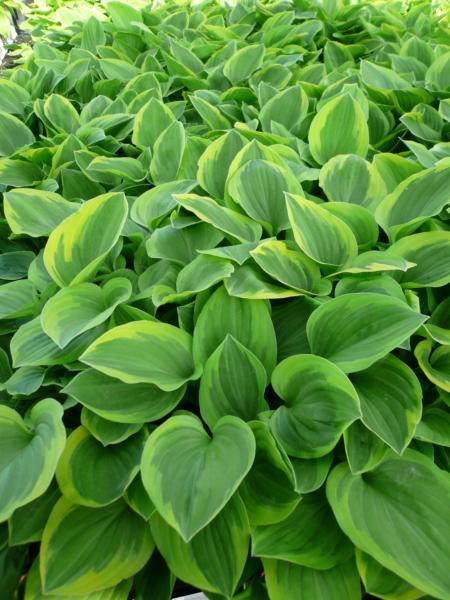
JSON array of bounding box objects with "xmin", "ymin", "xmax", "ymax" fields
[{"xmin": 44, "ymin": 192, "xmax": 128, "ymax": 287}]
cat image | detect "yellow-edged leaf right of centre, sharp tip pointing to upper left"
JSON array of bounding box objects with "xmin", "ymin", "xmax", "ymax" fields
[{"xmin": 286, "ymin": 194, "xmax": 358, "ymax": 266}]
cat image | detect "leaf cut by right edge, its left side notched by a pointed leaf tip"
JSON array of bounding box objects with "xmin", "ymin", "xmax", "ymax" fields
[{"xmin": 390, "ymin": 231, "xmax": 450, "ymax": 289}]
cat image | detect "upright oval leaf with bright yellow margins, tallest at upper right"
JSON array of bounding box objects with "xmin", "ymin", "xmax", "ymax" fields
[{"xmin": 308, "ymin": 92, "xmax": 369, "ymax": 165}]
